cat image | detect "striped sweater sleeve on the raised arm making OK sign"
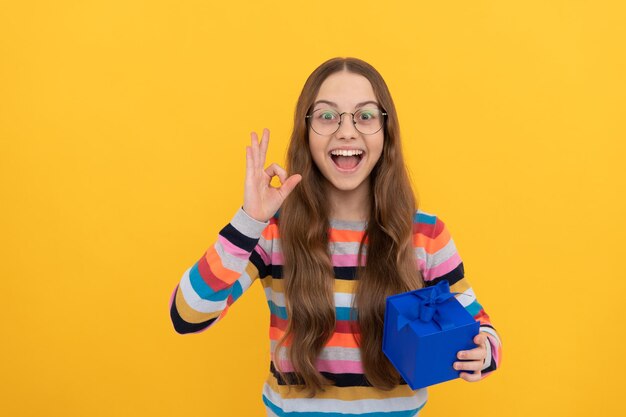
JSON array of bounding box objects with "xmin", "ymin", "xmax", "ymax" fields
[{"xmin": 170, "ymin": 208, "xmax": 269, "ymax": 334}]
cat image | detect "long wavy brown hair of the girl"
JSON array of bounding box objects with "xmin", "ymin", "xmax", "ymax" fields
[{"xmin": 274, "ymin": 58, "xmax": 424, "ymax": 396}]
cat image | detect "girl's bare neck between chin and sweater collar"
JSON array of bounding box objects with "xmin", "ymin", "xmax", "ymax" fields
[{"xmin": 327, "ymin": 181, "xmax": 370, "ymax": 221}]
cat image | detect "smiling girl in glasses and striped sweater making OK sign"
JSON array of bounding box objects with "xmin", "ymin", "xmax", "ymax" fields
[{"xmin": 170, "ymin": 58, "xmax": 501, "ymax": 417}]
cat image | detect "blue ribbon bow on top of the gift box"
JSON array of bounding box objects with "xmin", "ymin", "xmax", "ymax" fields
[{"xmin": 398, "ymin": 281, "xmax": 467, "ymax": 331}]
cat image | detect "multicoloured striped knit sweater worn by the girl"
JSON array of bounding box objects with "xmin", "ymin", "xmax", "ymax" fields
[{"xmin": 170, "ymin": 209, "xmax": 501, "ymax": 417}]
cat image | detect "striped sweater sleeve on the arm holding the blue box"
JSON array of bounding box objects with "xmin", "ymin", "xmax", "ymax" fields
[{"xmin": 415, "ymin": 210, "xmax": 502, "ymax": 378}]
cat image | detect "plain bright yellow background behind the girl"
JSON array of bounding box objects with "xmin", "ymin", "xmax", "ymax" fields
[{"xmin": 0, "ymin": 0, "xmax": 626, "ymax": 417}]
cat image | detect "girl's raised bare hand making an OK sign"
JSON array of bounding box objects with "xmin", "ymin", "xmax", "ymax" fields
[{"xmin": 243, "ymin": 129, "xmax": 302, "ymax": 222}]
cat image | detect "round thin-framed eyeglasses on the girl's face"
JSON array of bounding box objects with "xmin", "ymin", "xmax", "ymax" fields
[{"xmin": 306, "ymin": 108, "xmax": 387, "ymax": 136}]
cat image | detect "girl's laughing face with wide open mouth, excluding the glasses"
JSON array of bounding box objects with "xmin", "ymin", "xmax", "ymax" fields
[{"xmin": 309, "ymin": 71, "xmax": 385, "ymax": 195}]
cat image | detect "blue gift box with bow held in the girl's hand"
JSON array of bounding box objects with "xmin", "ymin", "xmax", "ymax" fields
[{"xmin": 383, "ymin": 281, "xmax": 480, "ymax": 389}]
